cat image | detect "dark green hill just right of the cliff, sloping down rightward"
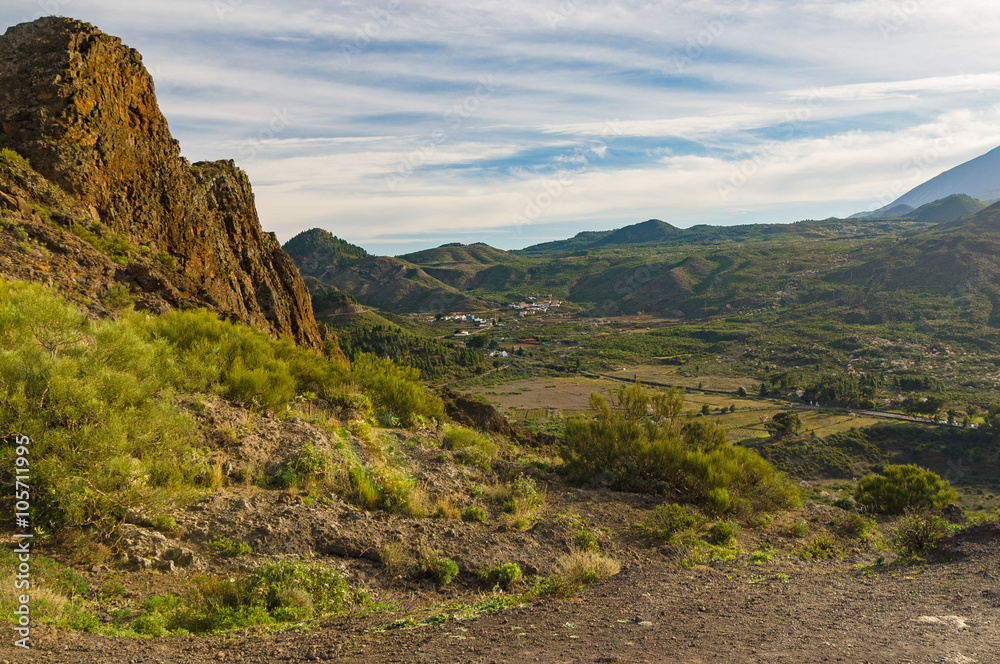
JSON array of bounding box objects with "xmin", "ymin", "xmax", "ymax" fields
[{"xmin": 284, "ymin": 228, "xmax": 486, "ymax": 313}]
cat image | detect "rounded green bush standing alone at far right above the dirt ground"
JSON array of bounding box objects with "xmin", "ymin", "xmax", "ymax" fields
[{"xmin": 854, "ymin": 464, "xmax": 958, "ymax": 514}]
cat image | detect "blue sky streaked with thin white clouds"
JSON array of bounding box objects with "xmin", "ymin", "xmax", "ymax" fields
[{"xmin": 0, "ymin": 0, "xmax": 1000, "ymax": 255}]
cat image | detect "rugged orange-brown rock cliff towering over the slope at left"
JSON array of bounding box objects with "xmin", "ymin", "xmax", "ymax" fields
[{"xmin": 0, "ymin": 17, "xmax": 324, "ymax": 348}]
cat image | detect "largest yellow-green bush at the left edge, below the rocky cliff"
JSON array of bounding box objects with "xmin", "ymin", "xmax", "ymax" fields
[{"xmin": 0, "ymin": 282, "xmax": 208, "ymax": 530}]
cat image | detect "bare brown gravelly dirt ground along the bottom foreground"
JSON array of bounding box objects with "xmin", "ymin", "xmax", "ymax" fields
[{"xmin": 0, "ymin": 523, "xmax": 1000, "ymax": 664}]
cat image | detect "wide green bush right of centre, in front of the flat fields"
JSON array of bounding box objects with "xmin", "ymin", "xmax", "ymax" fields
[{"xmin": 563, "ymin": 385, "xmax": 798, "ymax": 515}]
